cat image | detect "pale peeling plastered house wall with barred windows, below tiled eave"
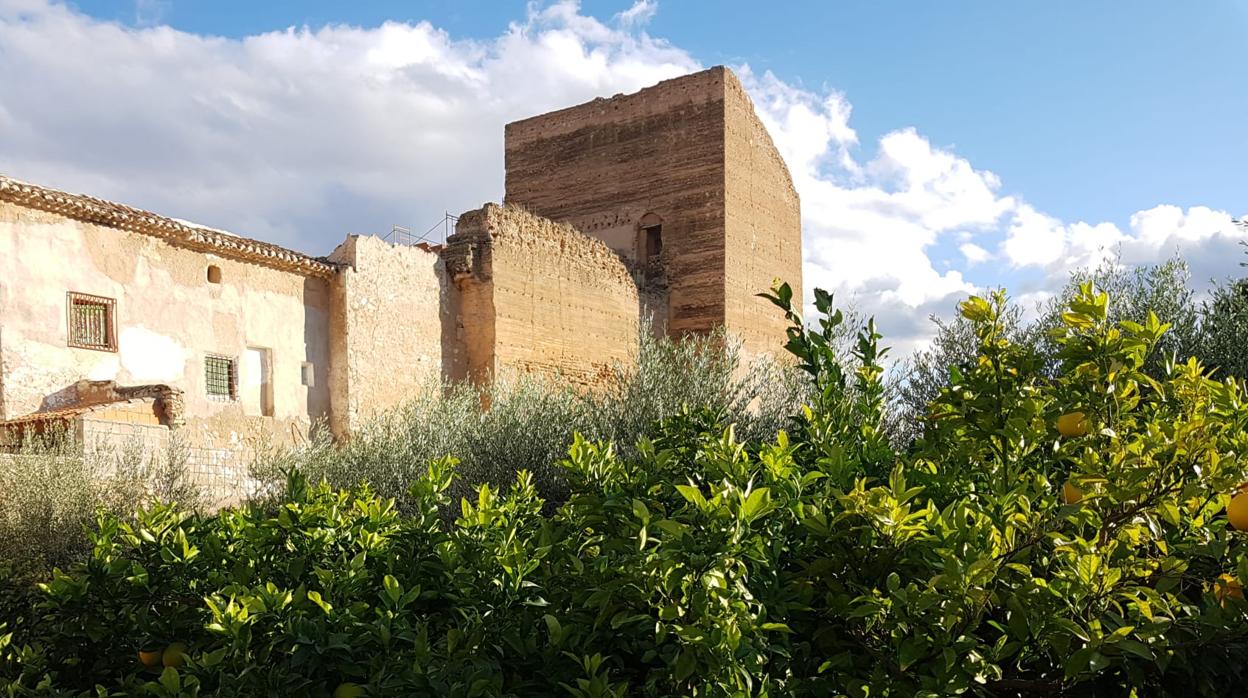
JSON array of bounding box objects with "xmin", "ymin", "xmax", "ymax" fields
[{"xmin": 0, "ymin": 201, "xmax": 331, "ymax": 443}]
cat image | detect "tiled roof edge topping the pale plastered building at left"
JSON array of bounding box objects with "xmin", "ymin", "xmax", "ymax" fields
[{"xmin": 0, "ymin": 175, "xmax": 338, "ymax": 278}]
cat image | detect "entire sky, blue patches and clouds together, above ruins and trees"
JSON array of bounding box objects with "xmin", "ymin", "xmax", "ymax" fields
[{"xmin": 0, "ymin": 0, "xmax": 1248, "ymax": 352}]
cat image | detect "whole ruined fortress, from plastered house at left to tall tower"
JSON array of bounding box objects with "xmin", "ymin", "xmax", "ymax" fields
[{"xmin": 0, "ymin": 67, "xmax": 801, "ymax": 486}]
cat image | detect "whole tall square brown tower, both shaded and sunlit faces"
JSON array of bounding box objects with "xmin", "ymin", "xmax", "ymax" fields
[{"xmin": 505, "ymin": 66, "xmax": 801, "ymax": 355}]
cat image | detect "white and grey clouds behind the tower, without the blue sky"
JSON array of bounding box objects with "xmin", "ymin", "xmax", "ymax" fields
[{"xmin": 0, "ymin": 0, "xmax": 1244, "ymax": 353}]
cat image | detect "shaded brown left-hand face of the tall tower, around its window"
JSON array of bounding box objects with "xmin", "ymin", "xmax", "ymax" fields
[{"xmin": 505, "ymin": 67, "xmax": 729, "ymax": 335}]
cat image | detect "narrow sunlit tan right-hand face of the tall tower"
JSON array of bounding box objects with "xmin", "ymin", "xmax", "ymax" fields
[{"xmin": 724, "ymin": 71, "xmax": 802, "ymax": 356}]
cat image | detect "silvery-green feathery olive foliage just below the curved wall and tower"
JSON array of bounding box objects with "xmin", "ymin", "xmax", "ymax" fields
[{"xmin": 256, "ymin": 333, "xmax": 806, "ymax": 509}]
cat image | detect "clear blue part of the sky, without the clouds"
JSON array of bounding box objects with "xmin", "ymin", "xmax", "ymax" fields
[{"xmin": 76, "ymin": 0, "xmax": 1248, "ymax": 227}]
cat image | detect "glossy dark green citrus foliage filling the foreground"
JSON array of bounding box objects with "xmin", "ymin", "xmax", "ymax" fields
[{"xmin": 0, "ymin": 277, "xmax": 1248, "ymax": 697}]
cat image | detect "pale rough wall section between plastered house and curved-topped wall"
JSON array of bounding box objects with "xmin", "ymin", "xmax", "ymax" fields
[{"xmin": 329, "ymin": 235, "xmax": 446, "ymax": 436}]
